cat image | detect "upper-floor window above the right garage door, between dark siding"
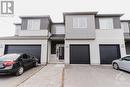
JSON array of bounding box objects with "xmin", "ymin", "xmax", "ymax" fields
[{"xmin": 99, "ymin": 18, "xmax": 113, "ymax": 29}]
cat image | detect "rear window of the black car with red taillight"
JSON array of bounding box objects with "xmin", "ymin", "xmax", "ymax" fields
[{"xmin": 0, "ymin": 54, "xmax": 20, "ymax": 61}]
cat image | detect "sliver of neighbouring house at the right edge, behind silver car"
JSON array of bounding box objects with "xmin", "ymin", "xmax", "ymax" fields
[{"xmin": 121, "ymin": 20, "xmax": 130, "ymax": 55}]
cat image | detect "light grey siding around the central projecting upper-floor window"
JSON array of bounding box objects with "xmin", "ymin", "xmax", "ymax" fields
[{"xmin": 65, "ymin": 15, "xmax": 96, "ymax": 40}]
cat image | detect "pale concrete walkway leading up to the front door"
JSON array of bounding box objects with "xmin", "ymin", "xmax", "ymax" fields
[{"xmin": 18, "ymin": 64, "xmax": 64, "ymax": 87}]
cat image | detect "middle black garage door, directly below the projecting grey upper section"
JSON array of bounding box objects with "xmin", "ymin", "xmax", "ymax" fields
[{"xmin": 70, "ymin": 45, "xmax": 90, "ymax": 64}]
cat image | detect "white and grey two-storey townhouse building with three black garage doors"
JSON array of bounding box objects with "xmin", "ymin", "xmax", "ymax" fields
[{"xmin": 0, "ymin": 12, "xmax": 126, "ymax": 64}]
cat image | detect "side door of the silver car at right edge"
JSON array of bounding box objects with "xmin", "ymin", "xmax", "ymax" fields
[{"xmin": 120, "ymin": 56, "xmax": 130, "ymax": 71}]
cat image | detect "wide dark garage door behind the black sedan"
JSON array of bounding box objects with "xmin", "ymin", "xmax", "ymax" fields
[{"xmin": 5, "ymin": 45, "xmax": 41, "ymax": 63}]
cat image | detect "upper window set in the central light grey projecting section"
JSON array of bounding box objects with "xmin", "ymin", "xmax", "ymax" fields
[{"xmin": 73, "ymin": 17, "xmax": 87, "ymax": 28}]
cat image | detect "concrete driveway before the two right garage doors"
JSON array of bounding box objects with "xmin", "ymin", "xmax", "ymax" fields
[{"xmin": 64, "ymin": 65, "xmax": 130, "ymax": 87}]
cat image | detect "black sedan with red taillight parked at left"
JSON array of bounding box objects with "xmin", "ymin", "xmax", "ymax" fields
[{"xmin": 0, "ymin": 53, "xmax": 38, "ymax": 76}]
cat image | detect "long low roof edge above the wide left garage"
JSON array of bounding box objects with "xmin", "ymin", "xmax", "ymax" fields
[{"xmin": 0, "ymin": 36, "xmax": 48, "ymax": 40}]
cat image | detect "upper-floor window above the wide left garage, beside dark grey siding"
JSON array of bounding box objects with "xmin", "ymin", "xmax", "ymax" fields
[{"xmin": 27, "ymin": 19, "xmax": 40, "ymax": 30}]
